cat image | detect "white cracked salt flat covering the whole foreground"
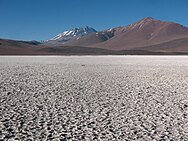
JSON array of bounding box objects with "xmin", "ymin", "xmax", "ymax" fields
[{"xmin": 0, "ymin": 56, "xmax": 188, "ymax": 141}]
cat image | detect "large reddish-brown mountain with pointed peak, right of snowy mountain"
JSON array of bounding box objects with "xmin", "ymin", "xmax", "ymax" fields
[{"xmin": 65, "ymin": 17, "xmax": 188, "ymax": 50}]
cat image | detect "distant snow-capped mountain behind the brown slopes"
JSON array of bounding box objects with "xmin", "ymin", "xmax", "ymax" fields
[{"xmin": 47, "ymin": 26, "xmax": 97, "ymax": 43}]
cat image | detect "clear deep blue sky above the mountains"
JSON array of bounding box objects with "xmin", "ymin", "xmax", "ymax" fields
[{"xmin": 0, "ymin": 0, "xmax": 188, "ymax": 41}]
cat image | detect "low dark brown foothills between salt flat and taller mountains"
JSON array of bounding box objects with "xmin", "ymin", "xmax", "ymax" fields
[{"xmin": 0, "ymin": 38, "xmax": 188, "ymax": 55}]
